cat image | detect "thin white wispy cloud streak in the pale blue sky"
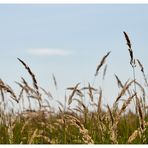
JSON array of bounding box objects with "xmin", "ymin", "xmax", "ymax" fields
[{"xmin": 27, "ymin": 48, "xmax": 72, "ymax": 56}]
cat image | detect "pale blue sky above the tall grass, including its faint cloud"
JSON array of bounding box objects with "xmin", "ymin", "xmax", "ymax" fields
[{"xmin": 0, "ymin": 4, "xmax": 148, "ymax": 104}]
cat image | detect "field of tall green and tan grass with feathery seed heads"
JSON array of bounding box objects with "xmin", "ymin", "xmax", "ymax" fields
[{"xmin": 0, "ymin": 32, "xmax": 148, "ymax": 144}]
